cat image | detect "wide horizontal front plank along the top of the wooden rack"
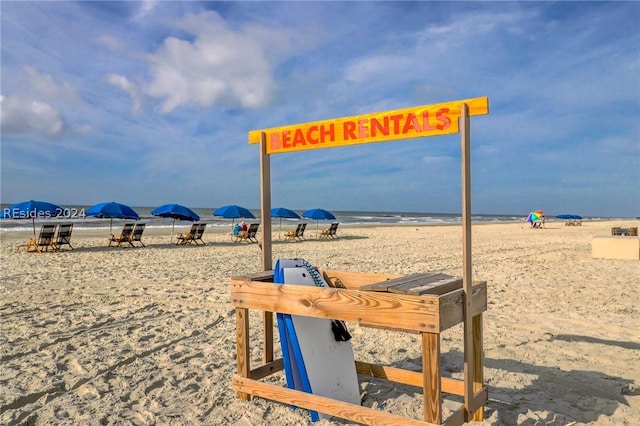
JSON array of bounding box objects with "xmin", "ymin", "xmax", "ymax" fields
[{"xmin": 231, "ymin": 280, "xmax": 440, "ymax": 332}]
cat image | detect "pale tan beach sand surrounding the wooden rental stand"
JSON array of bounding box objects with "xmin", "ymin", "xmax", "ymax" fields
[{"xmin": 0, "ymin": 221, "xmax": 640, "ymax": 426}]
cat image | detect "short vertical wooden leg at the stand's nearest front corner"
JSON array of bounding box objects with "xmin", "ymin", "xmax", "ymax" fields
[{"xmin": 422, "ymin": 333, "xmax": 442, "ymax": 424}]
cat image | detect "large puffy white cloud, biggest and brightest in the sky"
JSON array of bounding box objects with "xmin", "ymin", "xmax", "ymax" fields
[{"xmin": 146, "ymin": 12, "xmax": 286, "ymax": 113}]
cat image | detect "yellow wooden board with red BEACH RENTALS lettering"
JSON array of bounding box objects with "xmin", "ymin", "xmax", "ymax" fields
[{"xmin": 249, "ymin": 97, "xmax": 489, "ymax": 154}]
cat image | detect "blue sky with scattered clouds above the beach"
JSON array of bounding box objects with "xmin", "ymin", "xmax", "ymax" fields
[{"xmin": 0, "ymin": 1, "xmax": 640, "ymax": 217}]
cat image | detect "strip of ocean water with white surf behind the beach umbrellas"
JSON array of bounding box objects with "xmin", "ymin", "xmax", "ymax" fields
[{"xmin": 0, "ymin": 204, "xmax": 523, "ymax": 233}]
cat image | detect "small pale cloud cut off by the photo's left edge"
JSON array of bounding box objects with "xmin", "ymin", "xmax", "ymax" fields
[{"xmin": 0, "ymin": 96, "xmax": 64, "ymax": 137}]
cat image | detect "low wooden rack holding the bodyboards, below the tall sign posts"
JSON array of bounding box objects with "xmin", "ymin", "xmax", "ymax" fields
[{"xmin": 231, "ymin": 270, "xmax": 488, "ymax": 425}]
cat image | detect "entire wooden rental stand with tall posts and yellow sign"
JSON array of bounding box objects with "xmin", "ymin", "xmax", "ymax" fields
[{"xmin": 231, "ymin": 97, "xmax": 489, "ymax": 424}]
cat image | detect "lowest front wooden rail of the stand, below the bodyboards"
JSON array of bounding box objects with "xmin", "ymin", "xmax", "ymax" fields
[{"xmin": 233, "ymin": 376, "xmax": 435, "ymax": 426}]
